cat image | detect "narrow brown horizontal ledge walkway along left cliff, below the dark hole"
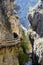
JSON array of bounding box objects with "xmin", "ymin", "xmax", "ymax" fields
[{"xmin": 0, "ymin": 39, "xmax": 20, "ymax": 48}]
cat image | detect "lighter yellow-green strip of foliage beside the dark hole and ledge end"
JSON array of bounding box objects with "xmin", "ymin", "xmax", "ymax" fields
[{"xmin": 21, "ymin": 32, "xmax": 29, "ymax": 53}]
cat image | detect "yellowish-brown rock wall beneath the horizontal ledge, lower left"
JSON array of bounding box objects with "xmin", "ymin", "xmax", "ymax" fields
[{"xmin": 0, "ymin": 47, "xmax": 19, "ymax": 65}]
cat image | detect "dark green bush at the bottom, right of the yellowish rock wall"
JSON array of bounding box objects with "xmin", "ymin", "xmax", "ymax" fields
[{"xmin": 18, "ymin": 52, "xmax": 29, "ymax": 65}]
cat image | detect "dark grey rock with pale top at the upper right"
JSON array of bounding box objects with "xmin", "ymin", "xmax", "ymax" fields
[{"xmin": 28, "ymin": 1, "xmax": 43, "ymax": 37}]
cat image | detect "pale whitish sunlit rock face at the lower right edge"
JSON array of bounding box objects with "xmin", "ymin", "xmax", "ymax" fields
[{"xmin": 34, "ymin": 38, "xmax": 43, "ymax": 63}]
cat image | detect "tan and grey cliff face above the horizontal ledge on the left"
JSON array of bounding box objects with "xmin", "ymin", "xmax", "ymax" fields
[{"xmin": 0, "ymin": 0, "xmax": 20, "ymax": 39}]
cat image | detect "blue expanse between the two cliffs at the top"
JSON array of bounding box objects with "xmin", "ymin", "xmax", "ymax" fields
[{"xmin": 16, "ymin": 0, "xmax": 38, "ymax": 29}]
